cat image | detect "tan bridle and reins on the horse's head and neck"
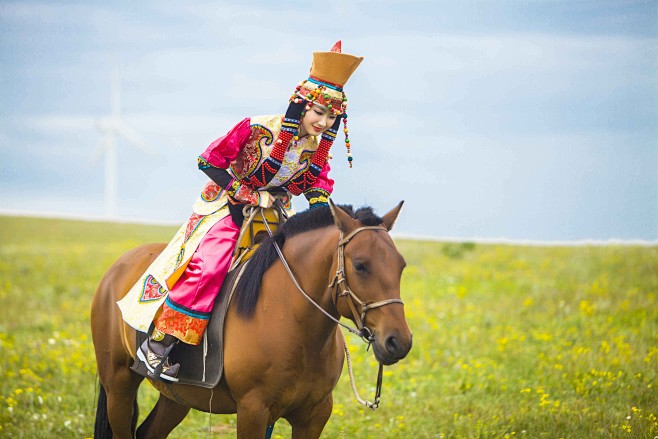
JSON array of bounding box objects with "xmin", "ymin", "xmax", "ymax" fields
[{"xmin": 261, "ymin": 205, "xmax": 403, "ymax": 410}]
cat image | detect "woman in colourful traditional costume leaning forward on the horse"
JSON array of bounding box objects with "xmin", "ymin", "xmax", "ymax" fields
[{"xmin": 118, "ymin": 41, "xmax": 363, "ymax": 382}]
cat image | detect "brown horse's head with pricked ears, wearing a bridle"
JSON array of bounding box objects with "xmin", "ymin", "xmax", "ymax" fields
[{"xmin": 330, "ymin": 201, "xmax": 412, "ymax": 365}]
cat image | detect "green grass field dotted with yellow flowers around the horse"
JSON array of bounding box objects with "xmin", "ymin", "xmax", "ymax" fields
[{"xmin": 0, "ymin": 217, "xmax": 658, "ymax": 438}]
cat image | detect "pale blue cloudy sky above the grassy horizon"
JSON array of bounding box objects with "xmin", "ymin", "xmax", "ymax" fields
[{"xmin": 0, "ymin": 0, "xmax": 658, "ymax": 240}]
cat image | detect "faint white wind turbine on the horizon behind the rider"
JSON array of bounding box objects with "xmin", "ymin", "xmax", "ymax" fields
[{"xmin": 92, "ymin": 68, "xmax": 155, "ymax": 219}]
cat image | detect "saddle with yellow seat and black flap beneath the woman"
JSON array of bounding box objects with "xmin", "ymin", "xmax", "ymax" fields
[{"xmin": 131, "ymin": 207, "xmax": 287, "ymax": 389}]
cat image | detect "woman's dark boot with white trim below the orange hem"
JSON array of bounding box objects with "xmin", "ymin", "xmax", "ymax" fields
[{"xmin": 137, "ymin": 328, "xmax": 180, "ymax": 382}]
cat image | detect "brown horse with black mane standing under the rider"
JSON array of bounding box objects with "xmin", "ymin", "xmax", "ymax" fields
[{"xmin": 91, "ymin": 203, "xmax": 411, "ymax": 438}]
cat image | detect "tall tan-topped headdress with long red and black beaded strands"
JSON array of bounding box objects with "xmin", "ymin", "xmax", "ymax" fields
[{"xmin": 246, "ymin": 41, "xmax": 363, "ymax": 194}]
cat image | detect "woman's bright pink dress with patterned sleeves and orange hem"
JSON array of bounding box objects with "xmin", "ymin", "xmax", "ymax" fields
[{"xmin": 154, "ymin": 116, "xmax": 333, "ymax": 344}]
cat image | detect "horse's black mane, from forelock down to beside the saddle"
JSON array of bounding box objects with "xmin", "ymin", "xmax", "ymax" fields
[{"xmin": 235, "ymin": 205, "xmax": 384, "ymax": 317}]
